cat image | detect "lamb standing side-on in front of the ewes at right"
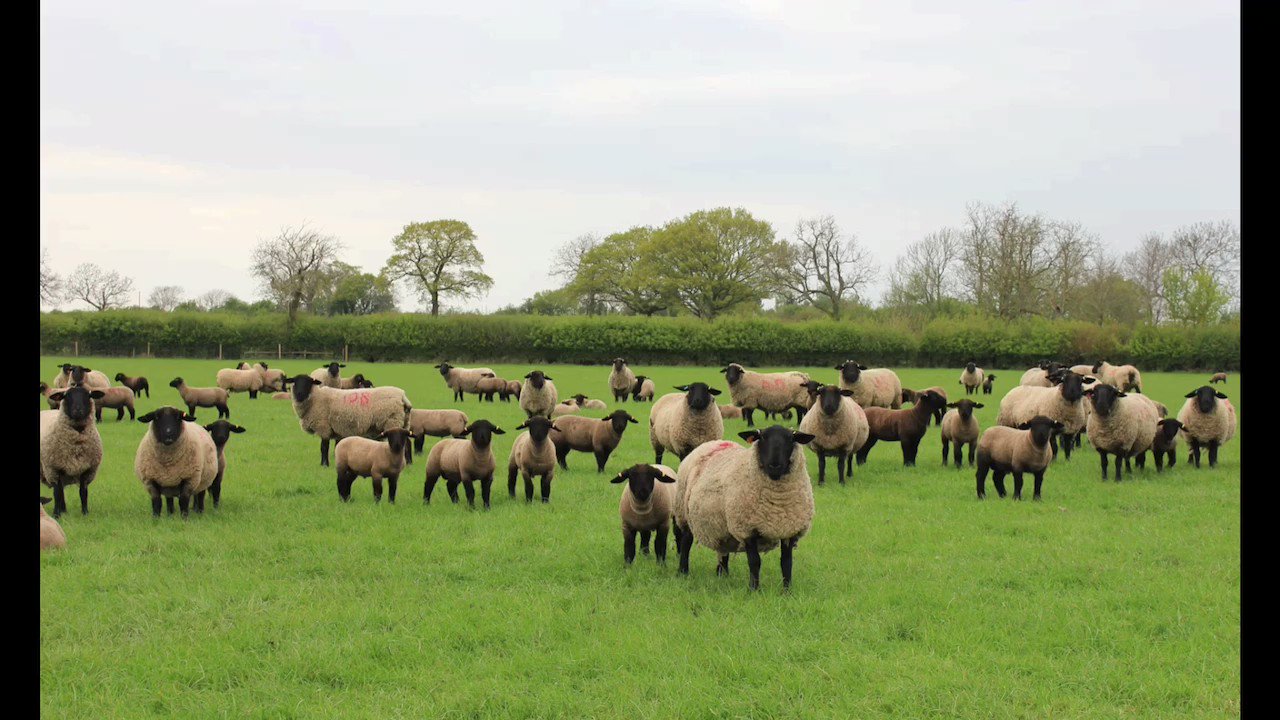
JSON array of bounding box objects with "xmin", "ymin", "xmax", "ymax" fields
[{"xmin": 975, "ymin": 415, "xmax": 1062, "ymax": 501}]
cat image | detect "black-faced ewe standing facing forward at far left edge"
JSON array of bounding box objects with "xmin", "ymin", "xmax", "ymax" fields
[{"xmin": 40, "ymin": 386, "xmax": 102, "ymax": 518}]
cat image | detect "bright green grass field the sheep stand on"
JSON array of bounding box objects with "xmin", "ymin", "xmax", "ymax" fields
[{"xmin": 38, "ymin": 357, "xmax": 1243, "ymax": 719}]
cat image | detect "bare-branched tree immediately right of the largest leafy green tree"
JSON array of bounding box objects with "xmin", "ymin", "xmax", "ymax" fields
[{"xmin": 772, "ymin": 215, "xmax": 877, "ymax": 320}]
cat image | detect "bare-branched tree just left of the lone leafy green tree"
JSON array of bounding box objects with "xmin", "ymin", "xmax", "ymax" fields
[{"xmin": 252, "ymin": 225, "xmax": 342, "ymax": 329}]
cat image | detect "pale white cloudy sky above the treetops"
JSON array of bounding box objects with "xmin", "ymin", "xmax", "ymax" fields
[{"xmin": 41, "ymin": 0, "xmax": 1240, "ymax": 309}]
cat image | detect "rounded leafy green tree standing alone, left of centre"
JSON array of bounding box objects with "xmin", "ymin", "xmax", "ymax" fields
[{"xmin": 383, "ymin": 220, "xmax": 493, "ymax": 315}]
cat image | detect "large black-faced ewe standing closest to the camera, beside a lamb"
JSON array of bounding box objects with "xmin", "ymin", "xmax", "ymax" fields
[{"xmin": 673, "ymin": 425, "xmax": 814, "ymax": 591}]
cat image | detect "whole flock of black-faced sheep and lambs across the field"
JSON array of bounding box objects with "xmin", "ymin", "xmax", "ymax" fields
[{"xmin": 40, "ymin": 357, "xmax": 1236, "ymax": 589}]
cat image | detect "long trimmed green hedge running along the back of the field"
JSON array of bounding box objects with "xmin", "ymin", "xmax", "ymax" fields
[{"xmin": 40, "ymin": 310, "xmax": 1240, "ymax": 370}]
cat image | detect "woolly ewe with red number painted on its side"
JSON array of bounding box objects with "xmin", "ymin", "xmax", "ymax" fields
[{"xmin": 292, "ymin": 375, "xmax": 413, "ymax": 468}]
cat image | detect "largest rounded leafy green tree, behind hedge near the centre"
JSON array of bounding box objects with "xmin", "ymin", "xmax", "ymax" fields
[{"xmin": 650, "ymin": 208, "xmax": 778, "ymax": 320}]
